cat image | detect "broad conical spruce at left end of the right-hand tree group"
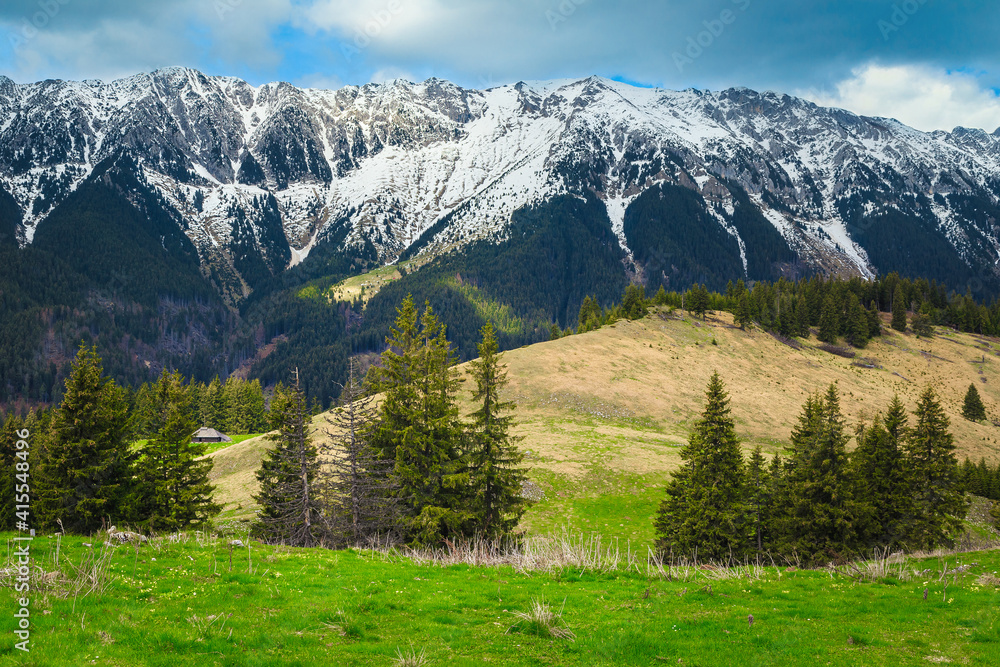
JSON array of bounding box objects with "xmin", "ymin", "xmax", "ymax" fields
[{"xmin": 654, "ymin": 373, "xmax": 748, "ymax": 560}]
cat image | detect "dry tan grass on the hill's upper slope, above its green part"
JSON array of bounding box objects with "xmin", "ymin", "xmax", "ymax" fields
[{"xmin": 488, "ymin": 313, "xmax": 1000, "ymax": 467}]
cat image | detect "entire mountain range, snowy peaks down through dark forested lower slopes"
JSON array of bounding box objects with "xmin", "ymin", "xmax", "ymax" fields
[{"xmin": 0, "ymin": 68, "xmax": 1000, "ymax": 403}]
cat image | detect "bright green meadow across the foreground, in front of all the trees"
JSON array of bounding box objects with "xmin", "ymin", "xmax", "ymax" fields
[{"xmin": 0, "ymin": 535, "xmax": 1000, "ymax": 667}]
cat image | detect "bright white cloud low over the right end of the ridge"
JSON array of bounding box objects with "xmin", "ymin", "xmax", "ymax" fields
[{"xmin": 797, "ymin": 64, "xmax": 1000, "ymax": 132}]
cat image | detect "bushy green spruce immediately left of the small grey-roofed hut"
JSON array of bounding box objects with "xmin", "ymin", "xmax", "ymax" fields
[{"xmin": 136, "ymin": 371, "xmax": 222, "ymax": 531}]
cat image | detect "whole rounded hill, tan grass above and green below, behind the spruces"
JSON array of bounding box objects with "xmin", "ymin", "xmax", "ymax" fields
[{"xmin": 212, "ymin": 311, "xmax": 1000, "ymax": 543}]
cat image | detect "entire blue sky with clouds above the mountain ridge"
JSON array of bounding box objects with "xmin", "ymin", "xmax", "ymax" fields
[{"xmin": 0, "ymin": 0, "xmax": 1000, "ymax": 131}]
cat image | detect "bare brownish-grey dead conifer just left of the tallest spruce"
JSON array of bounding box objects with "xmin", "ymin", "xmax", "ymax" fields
[{"xmin": 321, "ymin": 359, "xmax": 400, "ymax": 545}]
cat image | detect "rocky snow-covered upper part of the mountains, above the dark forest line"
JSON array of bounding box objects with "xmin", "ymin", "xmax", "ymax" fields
[{"xmin": 0, "ymin": 68, "xmax": 1000, "ymax": 294}]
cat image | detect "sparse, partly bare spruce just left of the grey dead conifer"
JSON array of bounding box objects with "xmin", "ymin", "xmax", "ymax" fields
[{"xmin": 254, "ymin": 369, "xmax": 329, "ymax": 547}]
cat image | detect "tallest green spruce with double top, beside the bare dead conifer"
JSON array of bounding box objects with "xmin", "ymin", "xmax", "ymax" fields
[{"xmin": 373, "ymin": 297, "xmax": 473, "ymax": 545}]
